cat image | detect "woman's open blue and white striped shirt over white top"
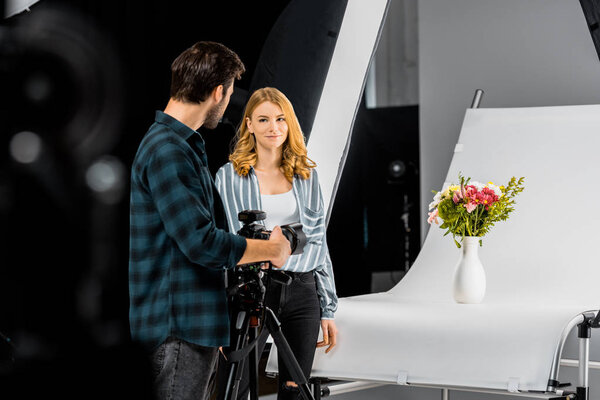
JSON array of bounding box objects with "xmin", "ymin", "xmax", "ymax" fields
[{"xmin": 215, "ymin": 163, "xmax": 338, "ymax": 319}]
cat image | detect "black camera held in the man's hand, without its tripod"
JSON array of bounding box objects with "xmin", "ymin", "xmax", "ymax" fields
[{"xmin": 237, "ymin": 210, "xmax": 306, "ymax": 255}]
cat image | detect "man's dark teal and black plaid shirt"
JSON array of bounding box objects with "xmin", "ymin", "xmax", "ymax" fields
[{"xmin": 129, "ymin": 111, "xmax": 246, "ymax": 348}]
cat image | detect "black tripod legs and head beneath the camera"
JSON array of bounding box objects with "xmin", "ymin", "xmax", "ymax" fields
[{"xmin": 222, "ymin": 265, "xmax": 314, "ymax": 400}]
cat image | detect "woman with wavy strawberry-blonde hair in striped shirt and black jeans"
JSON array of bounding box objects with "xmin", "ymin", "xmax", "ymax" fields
[{"xmin": 216, "ymin": 87, "xmax": 338, "ymax": 399}]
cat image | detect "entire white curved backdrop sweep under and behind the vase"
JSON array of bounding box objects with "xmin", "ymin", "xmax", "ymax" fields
[{"xmin": 270, "ymin": 105, "xmax": 600, "ymax": 391}]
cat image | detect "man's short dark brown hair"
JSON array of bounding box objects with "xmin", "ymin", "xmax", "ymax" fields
[{"xmin": 171, "ymin": 42, "xmax": 246, "ymax": 103}]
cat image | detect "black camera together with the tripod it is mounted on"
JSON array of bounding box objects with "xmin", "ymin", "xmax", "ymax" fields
[{"xmin": 219, "ymin": 210, "xmax": 314, "ymax": 400}]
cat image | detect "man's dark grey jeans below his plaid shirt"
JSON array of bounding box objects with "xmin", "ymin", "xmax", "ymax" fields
[{"xmin": 152, "ymin": 337, "xmax": 218, "ymax": 400}]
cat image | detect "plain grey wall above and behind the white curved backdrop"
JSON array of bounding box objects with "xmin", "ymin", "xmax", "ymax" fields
[{"xmin": 418, "ymin": 0, "xmax": 600, "ymax": 240}]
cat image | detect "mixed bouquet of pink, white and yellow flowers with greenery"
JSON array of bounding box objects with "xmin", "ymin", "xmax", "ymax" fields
[{"xmin": 427, "ymin": 174, "xmax": 525, "ymax": 248}]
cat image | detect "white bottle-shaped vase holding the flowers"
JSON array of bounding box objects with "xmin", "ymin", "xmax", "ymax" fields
[{"xmin": 454, "ymin": 236, "xmax": 486, "ymax": 304}]
